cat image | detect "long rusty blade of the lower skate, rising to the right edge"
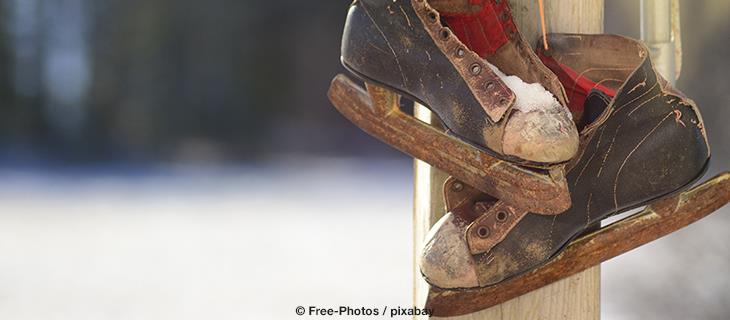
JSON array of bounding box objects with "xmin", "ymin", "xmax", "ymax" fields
[{"xmin": 426, "ymin": 172, "xmax": 730, "ymax": 317}]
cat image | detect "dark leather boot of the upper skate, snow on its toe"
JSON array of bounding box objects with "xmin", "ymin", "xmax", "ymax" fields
[{"xmin": 342, "ymin": 0, "xmax": 578, "ymax": 167}]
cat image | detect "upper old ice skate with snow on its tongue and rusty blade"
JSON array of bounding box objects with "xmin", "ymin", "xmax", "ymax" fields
[{"xmin": 330, "ymin": 0, "xmax": 578, "ymax": 213}]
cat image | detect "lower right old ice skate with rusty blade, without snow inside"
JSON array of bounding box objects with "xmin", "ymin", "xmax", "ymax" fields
[{"xmin": 421, "ymin": 34, "xmax": 730, "ymax": 315}]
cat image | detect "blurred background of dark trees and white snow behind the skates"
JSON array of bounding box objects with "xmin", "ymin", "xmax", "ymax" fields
[{"xmin": 0, "ymin": 0, "xmax": 730, "ymax": 319}]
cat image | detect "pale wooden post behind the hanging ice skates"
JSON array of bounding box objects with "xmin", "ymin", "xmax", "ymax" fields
[{"xmin": 413, "ymin": 0, "xmax": 604, "ymax": 320}]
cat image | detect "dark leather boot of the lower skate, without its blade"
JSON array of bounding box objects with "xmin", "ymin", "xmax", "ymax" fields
[{"xmin": 420, "ymin": 34, "xmax": 710, "ymax": 289}]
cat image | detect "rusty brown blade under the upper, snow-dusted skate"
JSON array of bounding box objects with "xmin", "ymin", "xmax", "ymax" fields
[{"xmin": 328, "ymin": 75, "xmax": 571, "ymax": 214}]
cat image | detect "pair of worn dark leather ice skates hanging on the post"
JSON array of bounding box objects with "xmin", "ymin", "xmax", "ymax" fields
[{"xmin": 329, "ymin": 0, "xmax": 730, "ymax": 315}]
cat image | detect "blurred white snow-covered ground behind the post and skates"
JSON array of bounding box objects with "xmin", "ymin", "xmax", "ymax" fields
[{"xmin": 0, "ymin": 160, "xmax": 730, "ymax": 320}]
